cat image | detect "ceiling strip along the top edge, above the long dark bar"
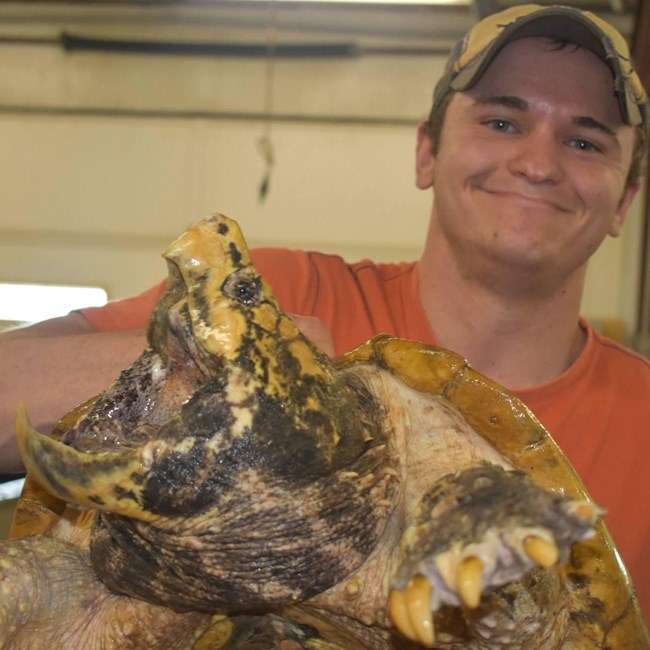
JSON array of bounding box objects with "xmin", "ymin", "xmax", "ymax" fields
[{"xmin": 0, "ymin": 0, "xmax": 642, "ymax": 51}]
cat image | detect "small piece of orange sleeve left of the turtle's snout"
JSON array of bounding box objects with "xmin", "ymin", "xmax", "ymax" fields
[{"xmin": 79, "ymin": 279, "xmax": 167, "ymax": 332}]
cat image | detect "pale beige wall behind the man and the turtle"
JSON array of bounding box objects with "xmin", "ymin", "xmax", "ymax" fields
[{"xmin": 0, "ymin": 5, "xmax": 640, "ymax": 336}]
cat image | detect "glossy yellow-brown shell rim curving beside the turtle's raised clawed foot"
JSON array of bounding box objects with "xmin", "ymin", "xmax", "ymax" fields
[{"xmin": 337, "ymin": 336, "xmax": 650, "ymax": 649}]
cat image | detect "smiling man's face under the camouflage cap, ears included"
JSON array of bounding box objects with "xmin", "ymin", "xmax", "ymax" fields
[{"xmin": 418, "ymin": 38, "xmax": 637, "ymax": 284}]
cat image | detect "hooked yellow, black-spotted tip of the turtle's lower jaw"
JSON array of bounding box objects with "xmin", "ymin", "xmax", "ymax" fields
[{"xmin": 16, "ymin": 403, "xmax": 159, "ymax": 522}]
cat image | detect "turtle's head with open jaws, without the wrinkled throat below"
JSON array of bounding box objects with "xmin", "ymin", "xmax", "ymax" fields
[{"xmin": 17, "ymin": 215, "xmax": 365, "ymax": 521}]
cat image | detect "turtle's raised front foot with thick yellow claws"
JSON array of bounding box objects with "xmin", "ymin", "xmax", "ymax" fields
[{"xmin": 389, "ymin": 463, "xmax": 599, "ymax": 648}]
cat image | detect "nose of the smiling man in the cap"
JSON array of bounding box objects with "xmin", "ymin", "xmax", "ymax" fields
[{"xmin": 508, "ymin": 129, "xmax": 564, "ymax": 183}]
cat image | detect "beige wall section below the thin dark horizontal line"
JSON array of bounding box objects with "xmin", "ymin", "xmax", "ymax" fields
[{"xmin": 0, "ymin": 116, "xmax": 429, "ymax": 297}]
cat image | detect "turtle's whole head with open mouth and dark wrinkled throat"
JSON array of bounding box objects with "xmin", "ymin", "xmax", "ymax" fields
[{"xmin": 17, "ymin": 216, "xmax": 385, "ymax": 611}]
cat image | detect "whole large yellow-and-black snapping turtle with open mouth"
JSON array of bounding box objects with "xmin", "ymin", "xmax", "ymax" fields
[{"xmin": 0, "ymin": 216, "xmax": 650, "ymax": 650}]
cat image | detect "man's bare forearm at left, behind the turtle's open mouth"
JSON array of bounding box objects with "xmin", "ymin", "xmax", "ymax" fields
[{"xmin": 0, "ymin": 313, "xmax": 145, "ymax": 474}]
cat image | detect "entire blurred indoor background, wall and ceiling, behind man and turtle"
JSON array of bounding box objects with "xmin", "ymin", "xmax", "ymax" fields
[{"xmin": 0, "ymin": 0, "xmax": 650, "ymax": 354}]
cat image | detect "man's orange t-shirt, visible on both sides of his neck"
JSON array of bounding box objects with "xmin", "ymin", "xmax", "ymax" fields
[{"xmin": 83, "ymin": 249, "xmax": 650, "ymax": 618}]
